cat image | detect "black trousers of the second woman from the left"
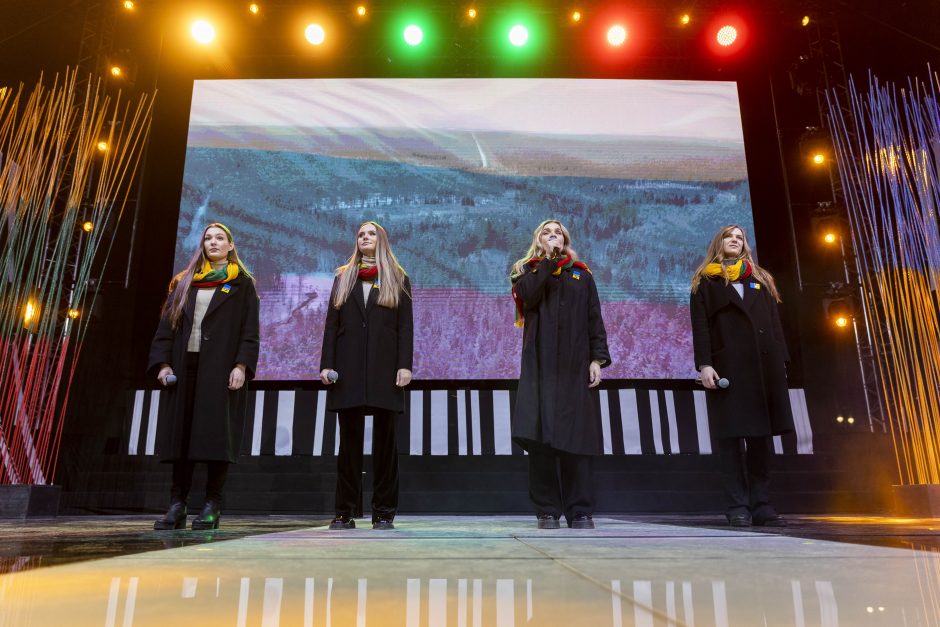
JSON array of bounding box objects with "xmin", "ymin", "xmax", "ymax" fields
[{"xmin": 336, "ymin": 407, "xmax": 398, "ymax": 522}]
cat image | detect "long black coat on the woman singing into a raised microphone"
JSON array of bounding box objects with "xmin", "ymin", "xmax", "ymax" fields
[{"xmin": 512, "ymin": 259, "xmax": 610, "ymax": 455}]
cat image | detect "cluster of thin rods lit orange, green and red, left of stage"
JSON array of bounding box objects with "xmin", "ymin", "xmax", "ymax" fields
[{"xmin": 0, "ymin": 70, "xmax": 153, "ymax": 485}]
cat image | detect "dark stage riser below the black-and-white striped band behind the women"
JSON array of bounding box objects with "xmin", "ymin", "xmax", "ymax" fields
[{"xmin": 62, "ymin": 454, "xmax": 880, "ymax": 517}]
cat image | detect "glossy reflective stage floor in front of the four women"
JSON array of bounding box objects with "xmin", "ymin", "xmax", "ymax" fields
[{"xmin": 0, "ymin": 515, "xmax": 940, "ymax": 627}]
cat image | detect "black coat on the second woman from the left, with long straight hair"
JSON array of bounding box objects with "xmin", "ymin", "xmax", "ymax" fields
[{"xmin": 320, "ymin": 277, "xmax": 414, "ymax": 412}]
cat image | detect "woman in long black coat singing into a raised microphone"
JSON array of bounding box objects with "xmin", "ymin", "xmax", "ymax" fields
[{"xmin": 509, "ymin": 220, "xmax": 610, "ymax": 529}]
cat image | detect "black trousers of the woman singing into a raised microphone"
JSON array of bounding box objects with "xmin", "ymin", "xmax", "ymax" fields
[{"xmin": 528, "ymin": 446, "xmax": 594, "ymax": 522}]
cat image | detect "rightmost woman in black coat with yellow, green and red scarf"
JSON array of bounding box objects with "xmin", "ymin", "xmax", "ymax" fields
[{"xmin": 689, "ymin": 224, "xmax": 793, "ymax": 527}]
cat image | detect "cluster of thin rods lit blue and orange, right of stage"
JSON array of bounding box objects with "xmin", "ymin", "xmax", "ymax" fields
[{"xmin": 829, "ymin": 74, "xmax": 940, "ymax": 485}]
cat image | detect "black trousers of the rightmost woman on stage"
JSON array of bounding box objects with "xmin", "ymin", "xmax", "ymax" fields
[{"xmin": 718, "ymin": 436, "xmax": 772, "ymax": 514}]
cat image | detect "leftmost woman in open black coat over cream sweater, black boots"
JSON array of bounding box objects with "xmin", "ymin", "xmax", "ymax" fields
[{"xmin": 148, "ymin": 223, "xmax": 259, "ymax": 529}]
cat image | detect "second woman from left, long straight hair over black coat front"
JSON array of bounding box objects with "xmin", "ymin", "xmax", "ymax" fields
[{"xmin": 320, "ymin": 222, "xmax": 414, "ymax": 529}]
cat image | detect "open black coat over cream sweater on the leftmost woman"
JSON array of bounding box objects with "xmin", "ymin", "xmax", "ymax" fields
[{"xmin": 147, "ymin": 276, "xmax": 260, "ymax": 462}]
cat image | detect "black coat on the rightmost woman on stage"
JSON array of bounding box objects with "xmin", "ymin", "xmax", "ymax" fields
[{"xmin": 689, "ymin": 278, "xmax": 793, "ymax": 438}]
